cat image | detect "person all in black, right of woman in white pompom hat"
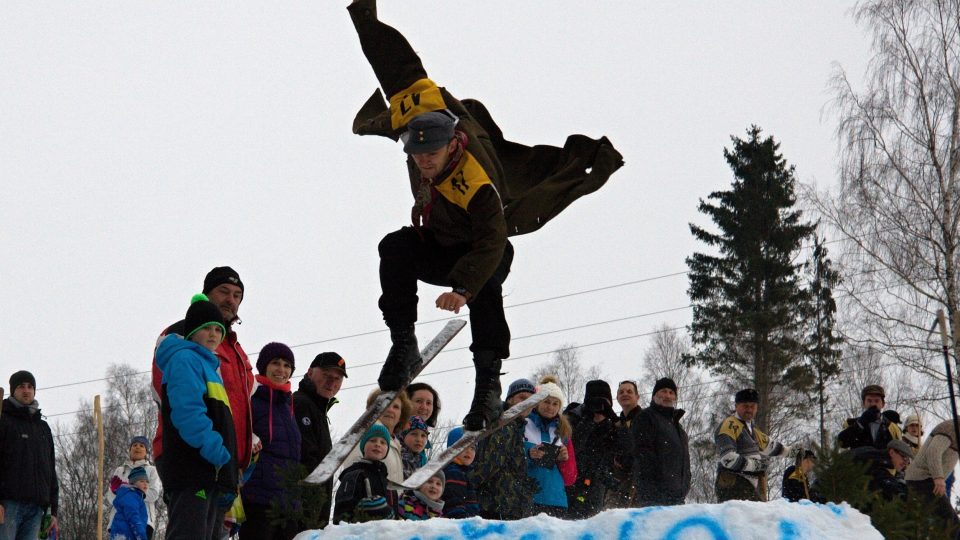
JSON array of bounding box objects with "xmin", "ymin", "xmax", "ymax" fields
[{"xmin": 567, "ymin": 380, "xmax": 632, "ymax": 519}]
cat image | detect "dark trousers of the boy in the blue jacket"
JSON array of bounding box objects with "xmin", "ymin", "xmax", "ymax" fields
[{"xmin": 165, "ymin": 489, "xmax": 224, "ymax": 540}]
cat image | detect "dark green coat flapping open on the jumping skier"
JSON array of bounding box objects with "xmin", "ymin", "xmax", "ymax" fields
[{"xmin": 348, "ymin": 0, "xmax": 623, "ymax": 294}]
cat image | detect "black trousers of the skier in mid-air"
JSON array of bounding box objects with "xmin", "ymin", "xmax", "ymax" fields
[{"xmin": 379, "ymin": 227, "xmax": 513, "ymax": 359}]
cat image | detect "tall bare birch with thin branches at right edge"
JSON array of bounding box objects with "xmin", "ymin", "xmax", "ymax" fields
[{"xmin": 812, "ymin": 0, "xmax": 960, "ymax": 380}]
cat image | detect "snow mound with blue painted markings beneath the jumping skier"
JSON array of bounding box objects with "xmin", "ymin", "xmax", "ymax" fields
[{"xmin": 296, "ymin": 499, "xmax": 883, "ymax": 540}]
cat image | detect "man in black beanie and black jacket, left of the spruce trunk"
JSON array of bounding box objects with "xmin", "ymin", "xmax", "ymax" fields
[{"xmin": 630, "ymin": 377, "xmax": 690, "ymax": 506}]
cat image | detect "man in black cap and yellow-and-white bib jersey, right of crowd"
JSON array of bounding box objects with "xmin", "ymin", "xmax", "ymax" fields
[{"xmin": 714, "ymin": 388, "xmax": 792, "ymax": 502}]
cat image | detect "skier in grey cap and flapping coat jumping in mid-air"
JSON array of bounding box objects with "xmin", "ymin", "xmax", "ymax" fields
[{"xmin": 348, "ymin": 0, "xmax": 622, "ymax": 430}]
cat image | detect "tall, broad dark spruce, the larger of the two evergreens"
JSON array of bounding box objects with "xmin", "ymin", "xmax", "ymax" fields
[{"xmin": 685, "ymin": 126, "xmax": 815, "ymax": 432}]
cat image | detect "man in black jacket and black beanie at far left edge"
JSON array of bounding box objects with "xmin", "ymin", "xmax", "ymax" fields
[{"xmin": 0, "ymin": 371, "xmax": 60, "ymax": 538}]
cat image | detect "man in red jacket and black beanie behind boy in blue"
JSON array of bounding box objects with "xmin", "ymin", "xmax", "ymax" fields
[{"xmin": 152, "ymin": 266, "xmax": 259, "ymax": 476}]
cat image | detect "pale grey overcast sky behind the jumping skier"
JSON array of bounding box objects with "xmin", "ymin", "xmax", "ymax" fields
[{"xmin": 0, "ymin": 0, "xmax": 869, "ymax": 432}]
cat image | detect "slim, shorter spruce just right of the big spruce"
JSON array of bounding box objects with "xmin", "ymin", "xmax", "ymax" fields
[{"xmin": 807, "ymin": 235, "xmax": 843, "ymax": 446}]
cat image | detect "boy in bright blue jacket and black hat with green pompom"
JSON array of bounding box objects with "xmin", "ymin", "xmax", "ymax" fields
[{"xmin": 156, "ymin": 294, "xmax": 239, "ymax": 540}]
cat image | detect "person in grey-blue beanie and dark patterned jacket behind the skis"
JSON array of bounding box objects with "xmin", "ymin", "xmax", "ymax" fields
[{"xmin": 473, "ymin": 379, "xmax": 540, "ymax": 520}]
